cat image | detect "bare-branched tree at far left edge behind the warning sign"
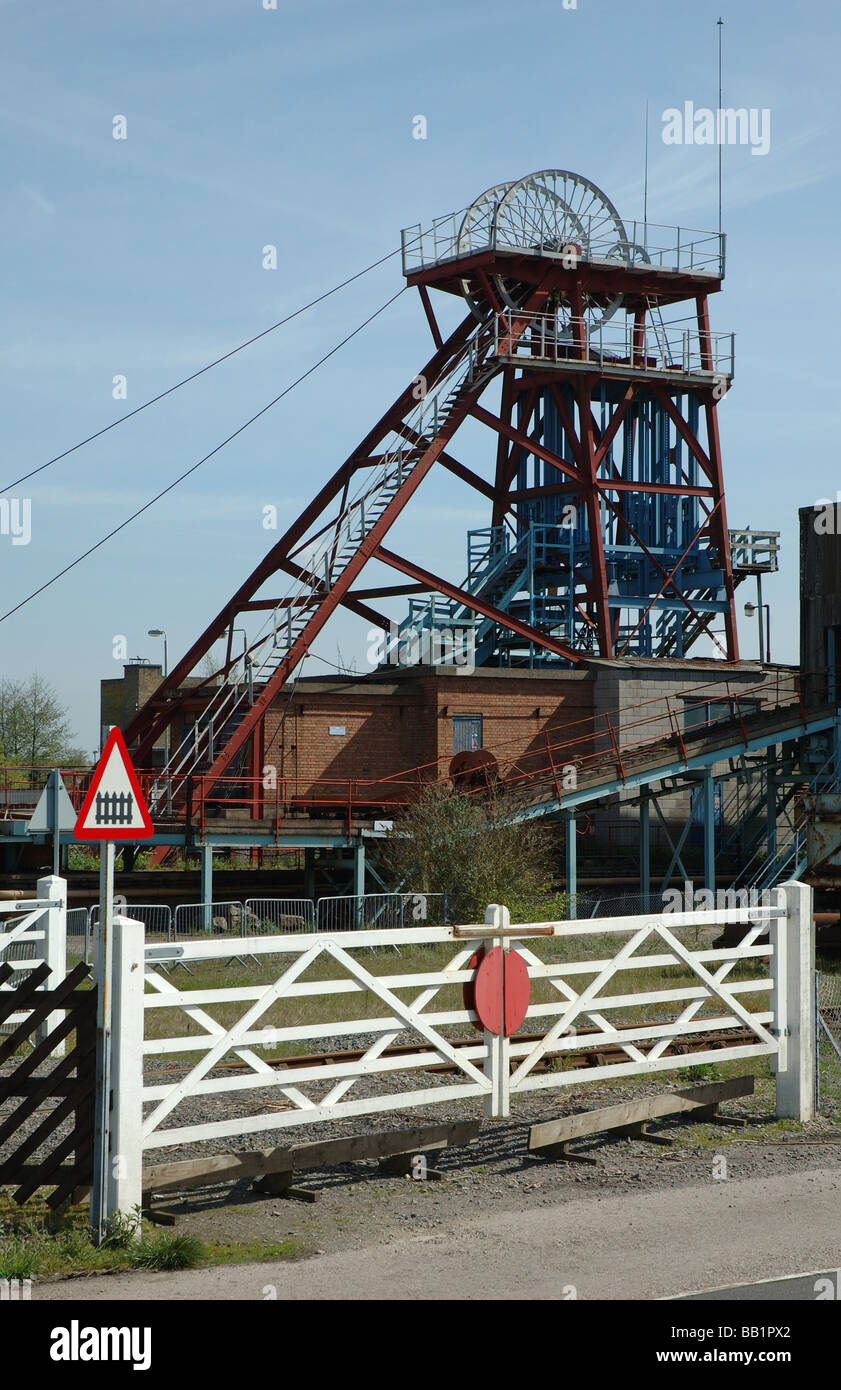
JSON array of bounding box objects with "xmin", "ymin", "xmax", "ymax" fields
[{"xmin": 0, "ymin": 674, "xmax": 89, "ymax": 767}]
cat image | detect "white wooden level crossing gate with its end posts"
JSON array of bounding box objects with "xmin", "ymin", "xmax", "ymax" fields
[{"xmin": 100, "ymin": 884, "xmax": 813, "ymax": 1209}]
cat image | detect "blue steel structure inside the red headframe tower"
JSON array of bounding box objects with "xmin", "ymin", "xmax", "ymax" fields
[{"xmin": 400, "ymin": 379, "xmax": 742, "ymax": 667}]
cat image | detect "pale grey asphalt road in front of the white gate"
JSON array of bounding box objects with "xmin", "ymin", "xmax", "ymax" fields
[{"xmin": 33, "ymin": 1168, "xmax": 841, "ymax": 1301}]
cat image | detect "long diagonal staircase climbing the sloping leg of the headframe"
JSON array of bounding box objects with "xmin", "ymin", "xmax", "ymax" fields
[{"xmin": 125, "ymin": 293, "xmax": 573, "ymax": 817}]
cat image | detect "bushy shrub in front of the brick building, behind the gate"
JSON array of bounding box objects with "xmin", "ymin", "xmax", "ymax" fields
[{"xmin": 372, "ymin": 785, "xmax": 555, "ymax": 922}]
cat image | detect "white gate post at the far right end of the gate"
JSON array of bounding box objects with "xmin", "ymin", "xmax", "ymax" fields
[{"xmin": 770, "ymin": 883, "xmax": 815, "ymax": 1120}]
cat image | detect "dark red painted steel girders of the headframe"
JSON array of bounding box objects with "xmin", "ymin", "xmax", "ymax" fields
[{"xmin": 114, "ymin": 209, "xmax": 738, "ymax": 816}]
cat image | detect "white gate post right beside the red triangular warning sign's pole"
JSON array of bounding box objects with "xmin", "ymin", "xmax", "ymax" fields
[{"xmin": 106, "ymin": 917, "xmax": 145, "ymax": 1216}]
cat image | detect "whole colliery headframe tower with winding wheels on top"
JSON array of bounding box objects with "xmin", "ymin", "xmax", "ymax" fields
[{"xmin": 126, "ymin": 170, "xmax": 738, "ymax": 811}]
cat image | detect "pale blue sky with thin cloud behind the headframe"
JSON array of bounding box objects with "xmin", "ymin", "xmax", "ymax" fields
[{"xmin": 0, "ymin": 0, "xmax": 841, "ymax": 751}]
